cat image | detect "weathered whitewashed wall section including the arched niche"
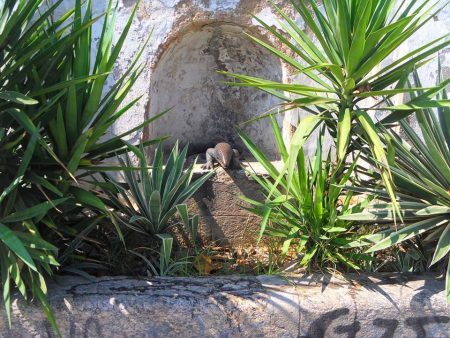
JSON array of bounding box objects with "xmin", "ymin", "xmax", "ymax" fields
[{"xmin": 52, "ymin": 0, "xmax": 298, "ymax": 155}]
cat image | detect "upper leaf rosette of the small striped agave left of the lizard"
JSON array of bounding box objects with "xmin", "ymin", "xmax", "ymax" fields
[{"xmin": 104, "ymin": 144, "xmax": 214, "ymax": 236}]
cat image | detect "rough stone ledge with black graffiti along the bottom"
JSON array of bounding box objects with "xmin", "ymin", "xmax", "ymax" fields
[{"xmin": 0, "ymin": 274, "xmax": 450, "ymax": 338}]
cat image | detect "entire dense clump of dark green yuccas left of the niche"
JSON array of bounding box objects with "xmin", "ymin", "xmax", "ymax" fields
[{"xmin": 0, "ymin": 0, "xmax": 165, "ymax": 330}]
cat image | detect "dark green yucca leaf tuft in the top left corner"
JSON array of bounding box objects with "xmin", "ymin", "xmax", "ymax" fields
[{"xmin": 0, "ymin": 0, "xmax": 67, "ymax": 101}]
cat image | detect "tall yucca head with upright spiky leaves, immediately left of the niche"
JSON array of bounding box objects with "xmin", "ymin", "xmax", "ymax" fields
[{"xmin": 21, "ymin": 0, "xmax": 167, "ymax": 199}]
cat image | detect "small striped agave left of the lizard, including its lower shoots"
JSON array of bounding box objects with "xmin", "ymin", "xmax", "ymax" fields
[{"xmin": 96, "ymin": 143, "xmax": 214, "ymax": 276}]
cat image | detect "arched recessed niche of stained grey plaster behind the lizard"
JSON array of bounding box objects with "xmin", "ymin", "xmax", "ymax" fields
[{"xmin": 148, "ymin": 23, "xmax": 283, "ymax": 159}]
